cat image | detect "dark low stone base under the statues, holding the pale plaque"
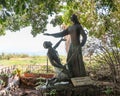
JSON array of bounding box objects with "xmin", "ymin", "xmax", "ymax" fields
[{"xmin": 38, "ymin": 77, "xmax": 100, "ymax": 96}]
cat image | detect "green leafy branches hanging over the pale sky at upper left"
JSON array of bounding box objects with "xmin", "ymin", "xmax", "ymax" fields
[{"xmin": 0, "ymin": 0, "xmax": 60, "ymax": 36}]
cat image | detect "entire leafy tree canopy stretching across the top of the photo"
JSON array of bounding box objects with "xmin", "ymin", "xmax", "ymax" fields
[{"xmin": 0, "ymin": 0, "xmax": 120, "ymax": 46}]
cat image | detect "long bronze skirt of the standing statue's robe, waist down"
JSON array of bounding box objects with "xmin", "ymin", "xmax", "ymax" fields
[{"xmin": 67, "ymin": 44, "xmax": 86, "ymax": 77}]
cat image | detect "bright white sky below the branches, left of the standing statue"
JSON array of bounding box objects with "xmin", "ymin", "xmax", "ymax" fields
[{"xmin": 0, "ymin": 24, "xmax": 66, "ymax": 55}]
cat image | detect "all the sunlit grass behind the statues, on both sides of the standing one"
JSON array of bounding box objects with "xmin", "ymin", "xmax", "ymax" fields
[{"xmin": 0, "ymin": 56, "xmax": 98, "ymax": 73}]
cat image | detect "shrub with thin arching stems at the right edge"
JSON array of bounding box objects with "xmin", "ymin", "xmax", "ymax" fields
[{"xmin": 96, "ymin": 46, "xmax": 120, "ymax": 84}]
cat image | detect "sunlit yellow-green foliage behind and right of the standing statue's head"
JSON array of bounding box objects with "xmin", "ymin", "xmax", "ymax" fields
[{"xmin": 63, "ymin": 0, "xmax": 120, "ymax": 47}]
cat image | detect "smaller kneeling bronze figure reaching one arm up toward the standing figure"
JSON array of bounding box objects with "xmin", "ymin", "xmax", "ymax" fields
[{"xmin": 43, "ymin": 39, "xmax": 69, "ymax": 81}]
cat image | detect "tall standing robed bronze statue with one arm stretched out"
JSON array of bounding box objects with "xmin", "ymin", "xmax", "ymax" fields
[{"xmin": 44, "ymin": 14, "xmax": 87, "ymax": 77}]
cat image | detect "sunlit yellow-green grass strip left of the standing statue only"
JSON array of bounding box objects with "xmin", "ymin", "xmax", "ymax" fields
[{"xmin": 0, "ymin": 56, "xmax": 66, "ymax": 66}]
